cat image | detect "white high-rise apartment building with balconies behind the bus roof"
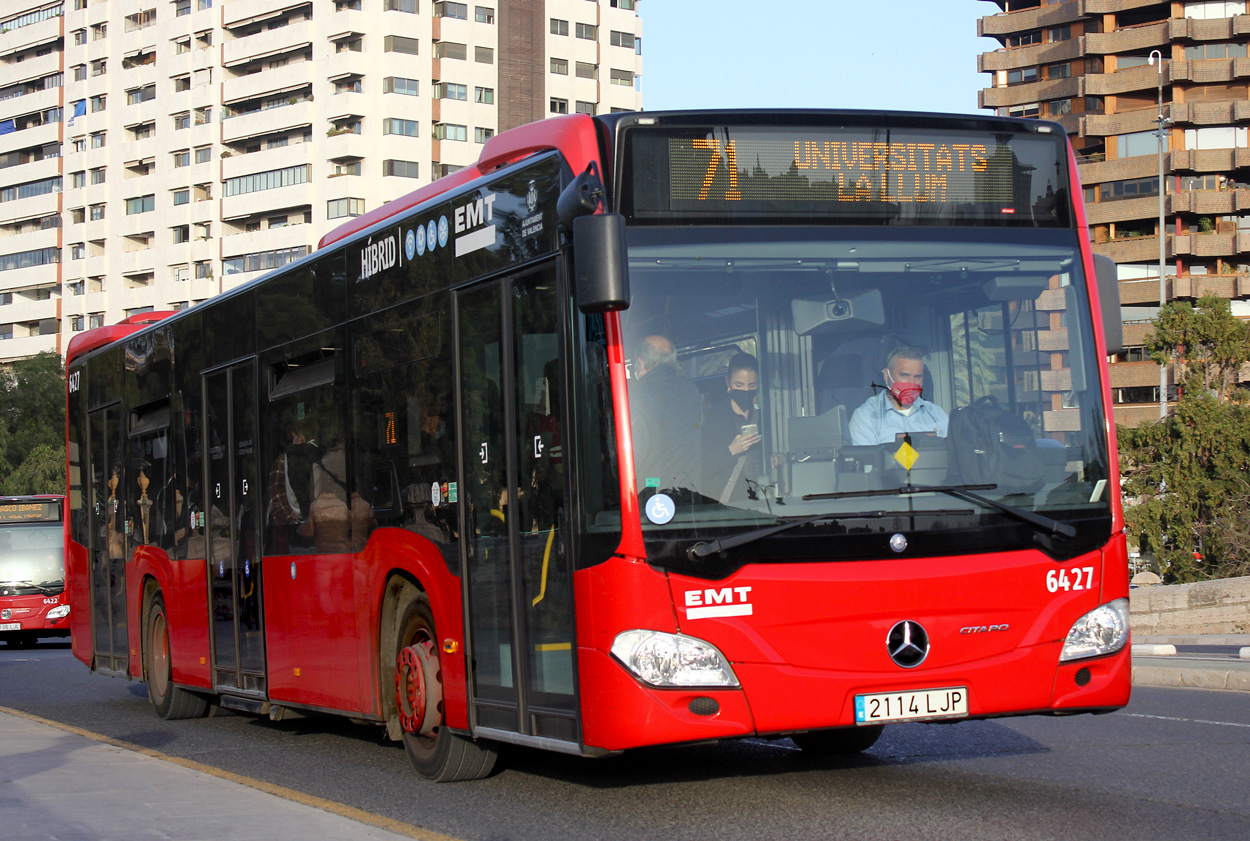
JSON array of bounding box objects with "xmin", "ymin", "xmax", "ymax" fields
[{"xmin": 0, "ymin": 0, "xmax": 643, "ymax": 362}]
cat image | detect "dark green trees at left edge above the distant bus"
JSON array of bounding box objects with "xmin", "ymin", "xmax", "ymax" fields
[{"xmin": 0, "ymin": 351, "xmax": 65, "ymax": 494}]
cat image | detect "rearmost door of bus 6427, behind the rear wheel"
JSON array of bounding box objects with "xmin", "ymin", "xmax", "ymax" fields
[{"xmin": 88, "ymin": 404, "xmax": 130, "ymax": 675}]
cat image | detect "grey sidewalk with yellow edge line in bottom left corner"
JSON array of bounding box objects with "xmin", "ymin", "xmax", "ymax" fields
[{"xmin": 0, "ymin": 711, "xmax": 454, "ymax": 841}]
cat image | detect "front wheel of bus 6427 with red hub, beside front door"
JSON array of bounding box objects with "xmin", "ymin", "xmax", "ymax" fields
[{"xmin": 395, "ymin": 595, "xmax": 499, "ymax": 782}]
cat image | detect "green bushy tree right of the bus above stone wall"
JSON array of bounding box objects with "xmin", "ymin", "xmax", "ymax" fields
[{"xmin": 1118, "ymin": 296, "xmax": 1250, "ymax": 581}]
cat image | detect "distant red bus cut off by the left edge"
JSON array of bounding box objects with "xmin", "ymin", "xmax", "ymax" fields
[{"xmin": 0, "ymin": 495, "xmax": 70, "ymax": 647}]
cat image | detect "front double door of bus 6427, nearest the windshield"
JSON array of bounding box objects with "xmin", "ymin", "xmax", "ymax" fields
[{"xmin": 456, "ymin": 262, "xmax": 580, "ymax": 751}]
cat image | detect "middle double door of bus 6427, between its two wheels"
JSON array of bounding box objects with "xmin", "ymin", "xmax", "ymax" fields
[{"xmin": 204, "ymin": 360, "xmax": 265, "ymax": 695}]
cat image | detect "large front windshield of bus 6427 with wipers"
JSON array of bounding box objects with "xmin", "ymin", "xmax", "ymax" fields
[{"xmin": 585, "ymin": 226, "xmax": 1110, "ymax": 571}]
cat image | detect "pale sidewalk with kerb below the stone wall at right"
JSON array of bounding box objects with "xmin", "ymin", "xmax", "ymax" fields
[{"xmin": 1133, "ymin": 634, "xmax": 1250, "ymax": 692}]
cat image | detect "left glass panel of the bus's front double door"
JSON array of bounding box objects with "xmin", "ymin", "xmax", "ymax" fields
[{"xmin": 459, "ymin": 278, "xmax": 516, "ymax": 709}]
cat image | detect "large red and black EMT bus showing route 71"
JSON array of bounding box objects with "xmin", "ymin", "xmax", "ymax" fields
[{"xmin": 60, "ymin": 111, "xmax": 1130, "ymax": 780}]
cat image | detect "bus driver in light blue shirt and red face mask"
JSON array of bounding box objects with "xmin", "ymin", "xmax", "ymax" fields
[{"xmin": 850, "ymin": 347, "xmax": 950, "ymax": 446}]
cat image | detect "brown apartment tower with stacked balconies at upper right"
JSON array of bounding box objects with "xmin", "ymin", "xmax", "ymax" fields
[{"xmin": 978, "ymin": 0, "xmax": 1250, "ymax": 426}]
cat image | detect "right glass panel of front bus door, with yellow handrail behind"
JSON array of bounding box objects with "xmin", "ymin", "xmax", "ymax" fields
[{"xmin": 511, "ymin": 270, "xmax": 574, "ymax": 711}]
